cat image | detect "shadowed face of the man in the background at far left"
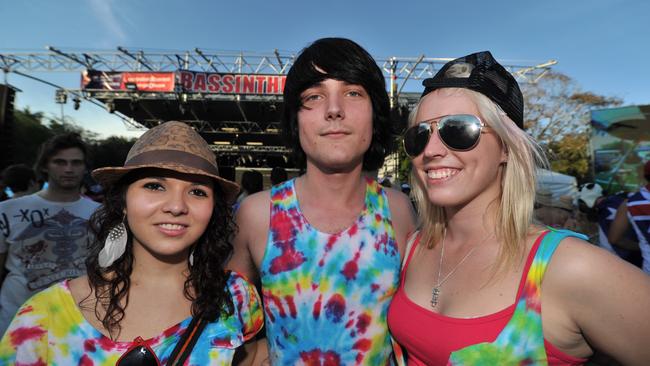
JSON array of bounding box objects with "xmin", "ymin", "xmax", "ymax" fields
[{"xmin": 45, "ymin": 147, "xmax": 86, "ymax": 190}]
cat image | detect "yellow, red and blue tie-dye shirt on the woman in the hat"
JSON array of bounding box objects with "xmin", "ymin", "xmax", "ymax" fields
[{"xmin": 0, "ymin": 272, "xmax": 263, "ymax": 366}]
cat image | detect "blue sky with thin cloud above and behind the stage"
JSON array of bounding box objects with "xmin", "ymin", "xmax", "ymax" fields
[{"xmin": 0, "ymin": 0, "xmax": 650, "ymax": 136}]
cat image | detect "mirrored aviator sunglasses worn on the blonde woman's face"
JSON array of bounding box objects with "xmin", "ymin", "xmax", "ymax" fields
[{"xmin": 403, "ymin": 114, "xmax": 489, "ymax": 158}]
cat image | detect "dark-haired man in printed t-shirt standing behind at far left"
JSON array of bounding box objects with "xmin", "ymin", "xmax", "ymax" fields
[{"xmin": 0, "ymin": 133, "xmax": 99, "ymax": 334}]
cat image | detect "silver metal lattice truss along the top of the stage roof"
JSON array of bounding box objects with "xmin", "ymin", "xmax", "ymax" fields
[{"xmin": 0, "ymin": 46, "xmax": 557, "ymax": 106}]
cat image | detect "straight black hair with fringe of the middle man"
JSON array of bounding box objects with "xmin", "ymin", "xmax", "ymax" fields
[{"xmin": 282, "ymin": 38, "xmax": 397, "ymax": 171}]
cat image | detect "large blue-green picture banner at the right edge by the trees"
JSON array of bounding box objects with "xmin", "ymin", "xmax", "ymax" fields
[{"xmin": 591, "ymin": 105, "xmax": 650, "ymax": 193}]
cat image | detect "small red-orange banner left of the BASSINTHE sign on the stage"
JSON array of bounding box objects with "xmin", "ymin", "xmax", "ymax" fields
[{"xmin": 81, "ymin": 70, "xmax": 176, "ymax": 92}]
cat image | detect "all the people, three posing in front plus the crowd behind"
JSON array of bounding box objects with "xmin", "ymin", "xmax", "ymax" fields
[{"xmin": 0, "ymin": 38, "xmax": 650, "ymax": 366}]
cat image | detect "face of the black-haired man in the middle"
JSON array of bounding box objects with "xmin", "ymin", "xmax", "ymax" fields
[{"xmin": 298, "ymin": 79, "xmax": 372, "ymax": 172}]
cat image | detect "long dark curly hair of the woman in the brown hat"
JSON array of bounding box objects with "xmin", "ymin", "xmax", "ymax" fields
[{"xmin": 80, "ymin": 172, "xmax": 236, "ymax": 336}]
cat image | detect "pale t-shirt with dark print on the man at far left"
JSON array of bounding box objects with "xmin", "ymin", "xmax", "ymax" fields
[{"xmin": 0, "ymin": 194, "xmax": 99, "ymax": 334}]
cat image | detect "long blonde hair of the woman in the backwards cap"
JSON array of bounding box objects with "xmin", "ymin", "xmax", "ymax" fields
[{"xmin": 409, "ymin": 88, "xmax": 548, "ymax": 268}]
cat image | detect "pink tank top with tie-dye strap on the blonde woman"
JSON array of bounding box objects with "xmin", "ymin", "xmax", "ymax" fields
[{"xmin": 388, "ymin": 230, "xmax": 587, "ymax": 366}]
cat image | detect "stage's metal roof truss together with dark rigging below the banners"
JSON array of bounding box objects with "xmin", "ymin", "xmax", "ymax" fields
[{"xmin": 0, "ymin": 46, "xmax": 557, "ymax": 169}]
